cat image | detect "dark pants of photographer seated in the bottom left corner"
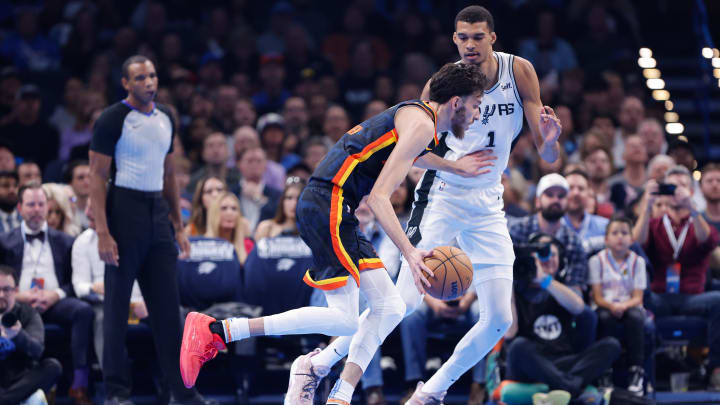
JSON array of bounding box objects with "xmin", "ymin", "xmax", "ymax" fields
[{"xmin": 0, "ymin": 358, "xmax": 62, "ymax": 405}]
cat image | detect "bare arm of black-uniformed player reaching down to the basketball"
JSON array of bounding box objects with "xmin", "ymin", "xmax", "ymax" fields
[{"xmin": 367, "ymin": 106, "xmax": 435, "ymax": 293}]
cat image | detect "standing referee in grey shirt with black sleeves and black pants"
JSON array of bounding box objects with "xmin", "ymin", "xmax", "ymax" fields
[{"xmin": 90, "ymin": 55, "xmax": 216, "ymax": 405}]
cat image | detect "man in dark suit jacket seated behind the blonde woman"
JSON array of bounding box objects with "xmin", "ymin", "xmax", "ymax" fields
[{"xmin": 230, "ymin": 147, "xmax": 282, "ymax": 230}]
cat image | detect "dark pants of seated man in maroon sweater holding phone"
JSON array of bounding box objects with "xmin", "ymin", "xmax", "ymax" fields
[{"xmin": 645, "ymin": 291, "xmax": 720, "ymax": 370}]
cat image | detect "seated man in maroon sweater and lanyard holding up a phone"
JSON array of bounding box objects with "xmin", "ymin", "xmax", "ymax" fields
[{"xmin": 633, "ymin": 165, "xmax": 720, "ymax": 390}]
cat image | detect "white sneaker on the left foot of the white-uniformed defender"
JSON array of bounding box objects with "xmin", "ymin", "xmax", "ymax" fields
[{"xmin": 284, "ymin": 349, "xmax": 330, "ymax": 405}]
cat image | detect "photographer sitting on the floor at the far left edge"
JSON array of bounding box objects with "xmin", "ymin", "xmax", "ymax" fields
[{"xmin": 0, "ymin": 265, "xmax": 62, "ymax": 405}]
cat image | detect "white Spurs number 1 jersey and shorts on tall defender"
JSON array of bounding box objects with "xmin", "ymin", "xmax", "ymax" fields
[{"xmin": 403, "ymin": 52, "xmax": 524, "ymax": 272}]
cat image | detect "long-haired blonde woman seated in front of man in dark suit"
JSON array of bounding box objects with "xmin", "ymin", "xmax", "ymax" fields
[{"xmin": 205, "ymin": 191, "xmax": 254, "ymax": 264}]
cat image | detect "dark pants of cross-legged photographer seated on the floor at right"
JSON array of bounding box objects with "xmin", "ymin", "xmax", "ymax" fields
[{"xmin": 507, "ymin": 337, "xmax": 620, "ymax": 396}]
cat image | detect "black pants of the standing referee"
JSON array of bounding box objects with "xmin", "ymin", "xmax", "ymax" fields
[{"xmin": 103, "ymin": 186, "xmax": 195, "ymax": 400}]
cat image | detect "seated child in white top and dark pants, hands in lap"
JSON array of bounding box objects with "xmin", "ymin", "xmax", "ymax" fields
[{"xmin": 589, "ymin": 217, "xmax": 647, "ymax": 395}]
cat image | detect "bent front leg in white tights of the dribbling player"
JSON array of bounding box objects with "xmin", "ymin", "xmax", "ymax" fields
[{"xmin": 328, "ymin": 269, "xmax": 405, "ymax": 404}]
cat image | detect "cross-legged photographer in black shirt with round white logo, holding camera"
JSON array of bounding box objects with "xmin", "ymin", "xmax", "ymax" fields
[{"xmin": 505, "ymin": 236, "xmax": 620, "ymax": 397}]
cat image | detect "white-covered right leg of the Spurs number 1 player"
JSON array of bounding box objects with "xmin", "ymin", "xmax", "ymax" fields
[{"xmin": 409, "ymin": 274, "xmax": 512, "ymax": 396}]
